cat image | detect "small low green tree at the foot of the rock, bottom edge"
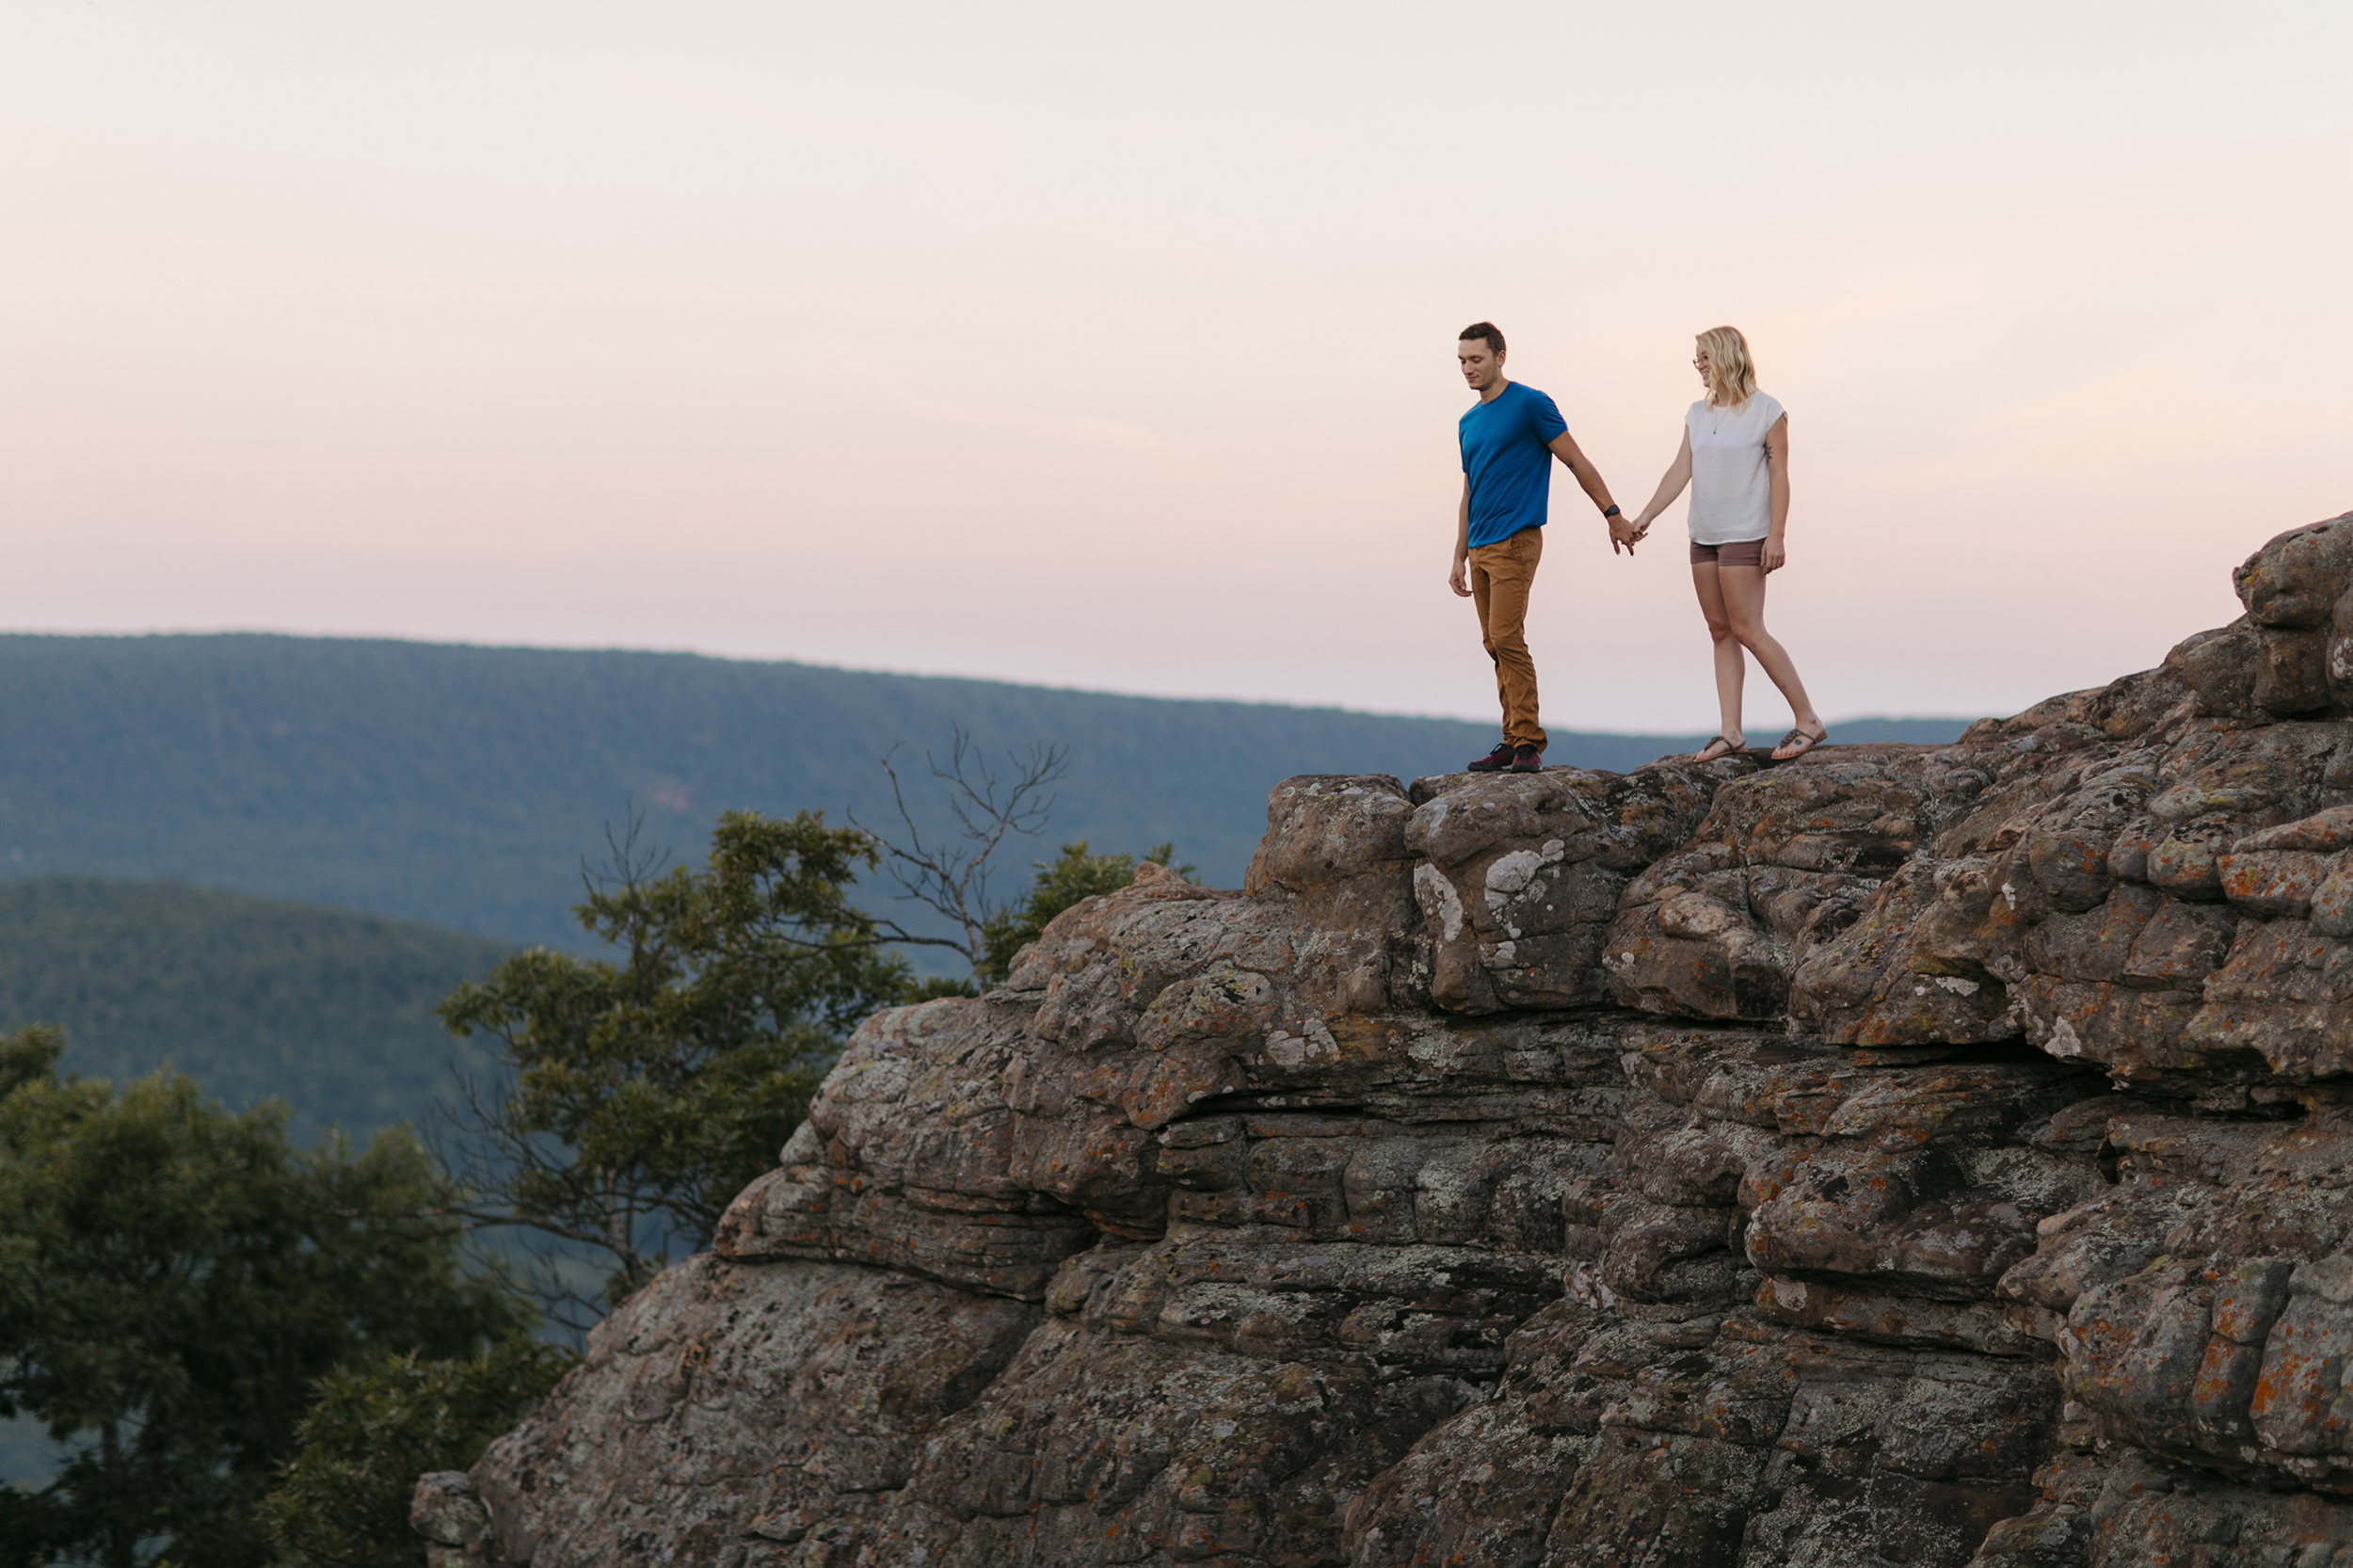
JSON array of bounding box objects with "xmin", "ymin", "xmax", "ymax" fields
[{"xmin": 262, "ymin": 1337, "xmax": 577, "ymax": 1568}]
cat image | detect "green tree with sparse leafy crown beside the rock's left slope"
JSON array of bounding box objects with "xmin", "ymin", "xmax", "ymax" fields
[{"xmin": 440, "ymin": 812, "xmax": 913, "ymax": 1304}]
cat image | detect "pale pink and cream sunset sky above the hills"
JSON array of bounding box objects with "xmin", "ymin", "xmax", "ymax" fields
[{"xmin": 0, "ymin": 0, "xmax": 2353, "ymax": 732}]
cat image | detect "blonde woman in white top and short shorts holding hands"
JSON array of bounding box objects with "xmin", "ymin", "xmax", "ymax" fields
[{"xmin": 1633, "ymin": 328, "xmax": 1831, "ymax": 762}]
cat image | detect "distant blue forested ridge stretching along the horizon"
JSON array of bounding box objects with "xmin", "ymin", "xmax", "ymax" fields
[{"xmin": 0, "ymin": 635, "xmax": 1961, "ymax": 944}]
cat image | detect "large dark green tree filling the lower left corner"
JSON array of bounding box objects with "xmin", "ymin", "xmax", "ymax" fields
[{"xmin": 0, "ymin": 1029, "xmax": 527, "ymax": 1568}]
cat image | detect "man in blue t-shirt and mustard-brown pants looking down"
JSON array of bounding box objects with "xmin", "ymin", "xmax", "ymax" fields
[{"xmin": 1448, "ymin": 320, "xmax": 1636, "ymax": 772}]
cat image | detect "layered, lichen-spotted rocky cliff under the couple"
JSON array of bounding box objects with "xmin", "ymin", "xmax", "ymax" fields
[{"xmin": 417, "ymin": 513, "xmax": 2353, "ymax": 1568}]
